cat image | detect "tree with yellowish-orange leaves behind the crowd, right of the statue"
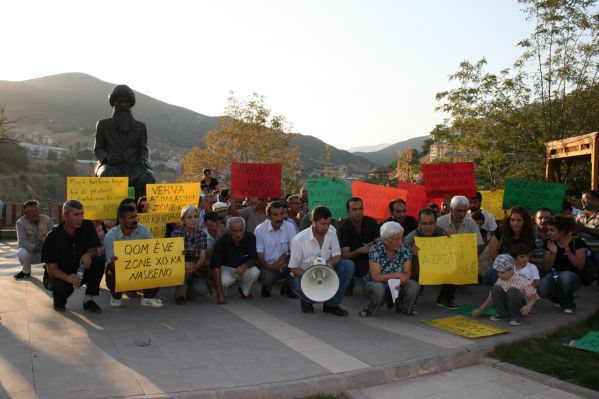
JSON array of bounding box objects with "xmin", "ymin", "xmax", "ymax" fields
[{"xmin": 181, "ymin": 93, "xmax": 301, "ymax": 192}]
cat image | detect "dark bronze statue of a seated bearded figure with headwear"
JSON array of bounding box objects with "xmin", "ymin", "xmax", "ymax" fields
[{"xmin": 94, "ymin": 85, "xmax": 156, "ymax": 197}]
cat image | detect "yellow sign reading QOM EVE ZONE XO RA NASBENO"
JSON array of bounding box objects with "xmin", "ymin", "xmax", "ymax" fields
[{"xmin": 114, "ymin": 237, "xmax": 185, "ymax": 292}]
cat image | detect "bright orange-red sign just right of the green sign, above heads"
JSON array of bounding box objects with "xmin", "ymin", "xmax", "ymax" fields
[{"xmin": 352, "ymin": 181, "xmax": 408, "ymax": 221}]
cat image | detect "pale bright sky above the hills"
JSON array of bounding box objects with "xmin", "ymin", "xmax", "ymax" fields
[{"xmin": 0, "ymin": 0, "xmax": 532, "ymax": 148}]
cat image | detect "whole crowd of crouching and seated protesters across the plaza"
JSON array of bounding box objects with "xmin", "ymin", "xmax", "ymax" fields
[{"xmin": 14, "ymin": 175, "xmax": 599, "ymax": 325}]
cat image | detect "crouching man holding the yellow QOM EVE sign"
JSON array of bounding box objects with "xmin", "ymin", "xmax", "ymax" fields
[{"xmin": 104, "ymin": 204, "xmax": 164, "ymax": 308}]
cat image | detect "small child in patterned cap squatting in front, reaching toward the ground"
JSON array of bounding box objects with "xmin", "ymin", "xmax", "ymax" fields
[{"xmin": 472, "ymin": 254, "xmax": 539, "ymax": 326}]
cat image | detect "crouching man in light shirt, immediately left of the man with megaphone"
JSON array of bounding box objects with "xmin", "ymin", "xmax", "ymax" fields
[{"xmin": 254, "ymin": 201, "xmax": 296, "ymax": 297}]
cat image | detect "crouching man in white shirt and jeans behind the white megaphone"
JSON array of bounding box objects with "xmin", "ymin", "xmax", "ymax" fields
[{"xmin": 289, "ymin": 206, "xmax": 355, "ymax": 316}]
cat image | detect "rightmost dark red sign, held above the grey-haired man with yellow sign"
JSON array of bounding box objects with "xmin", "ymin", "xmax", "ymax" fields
[{"xmin": 422, "ymin": 162, "xmax": 476, "ymax": 198}]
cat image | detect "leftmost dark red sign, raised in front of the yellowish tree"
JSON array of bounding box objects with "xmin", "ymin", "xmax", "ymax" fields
[{"xmin": 231, "ymin": 163, "xmax": 281, "ymax": 198}]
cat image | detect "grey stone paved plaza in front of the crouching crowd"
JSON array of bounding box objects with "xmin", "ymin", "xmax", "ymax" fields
[{"xmin": 0, "ymin": 242, "xmax": 599, "ymax": 398}]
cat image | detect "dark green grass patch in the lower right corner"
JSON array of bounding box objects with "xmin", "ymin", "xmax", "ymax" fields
[{"xmin": 490, "ymin": 312, "xmax": 599, "ymax": 390}]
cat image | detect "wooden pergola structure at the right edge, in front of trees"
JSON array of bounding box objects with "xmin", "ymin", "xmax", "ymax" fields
[{"xmin": 545, "ymin": 132, "xmax": 599, "ymax": 190}]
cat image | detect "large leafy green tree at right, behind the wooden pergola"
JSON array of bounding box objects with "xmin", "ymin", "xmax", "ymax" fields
[{"xmin": 434, "ymin": 0, "xmax": 599, "ymax": 187}]
